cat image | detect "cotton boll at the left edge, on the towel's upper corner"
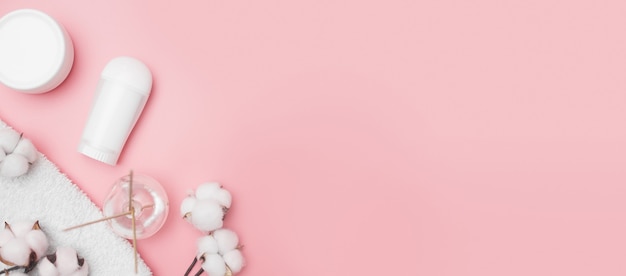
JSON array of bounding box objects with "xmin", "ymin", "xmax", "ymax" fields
[{"xmin": 0, "ymin": 128, "xmax": 38, "ymax": 177}]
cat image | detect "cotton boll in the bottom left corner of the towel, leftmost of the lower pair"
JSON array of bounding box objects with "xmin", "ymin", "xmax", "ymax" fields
[{"xmin": 0, "ymin": 221, "xmax": 48, "ymax": 272}]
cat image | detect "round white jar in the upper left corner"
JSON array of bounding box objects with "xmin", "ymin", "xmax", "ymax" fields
[{"xmin": 0, "ymin": 9, "xmax": 74, "ymax": 94}]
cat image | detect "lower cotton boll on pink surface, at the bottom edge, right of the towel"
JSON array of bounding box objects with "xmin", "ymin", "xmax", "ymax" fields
[{"xmin": 197, "ymin": 228, "xmax": 244, "ymax": 276}]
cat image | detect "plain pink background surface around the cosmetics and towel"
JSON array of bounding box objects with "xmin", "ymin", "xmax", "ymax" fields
[{"xmin": 0, "ymin": 0, "xmax": 626, "ymax": 276}]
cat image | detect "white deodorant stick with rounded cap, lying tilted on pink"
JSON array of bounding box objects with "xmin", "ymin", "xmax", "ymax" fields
[{"xmin": 78, "ymin": 57, "xmax": 152, "ymax": 165}]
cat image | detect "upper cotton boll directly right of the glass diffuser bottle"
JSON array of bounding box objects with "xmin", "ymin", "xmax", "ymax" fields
[{"xmin": 180, "ymin": 182, "xmax": 232, "ymax": 232}]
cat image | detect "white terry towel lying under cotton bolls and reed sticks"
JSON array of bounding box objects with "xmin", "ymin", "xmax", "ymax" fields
[{"xmin": 0, "ymin": 120, "xmax": 152, "ymax": 276}]
